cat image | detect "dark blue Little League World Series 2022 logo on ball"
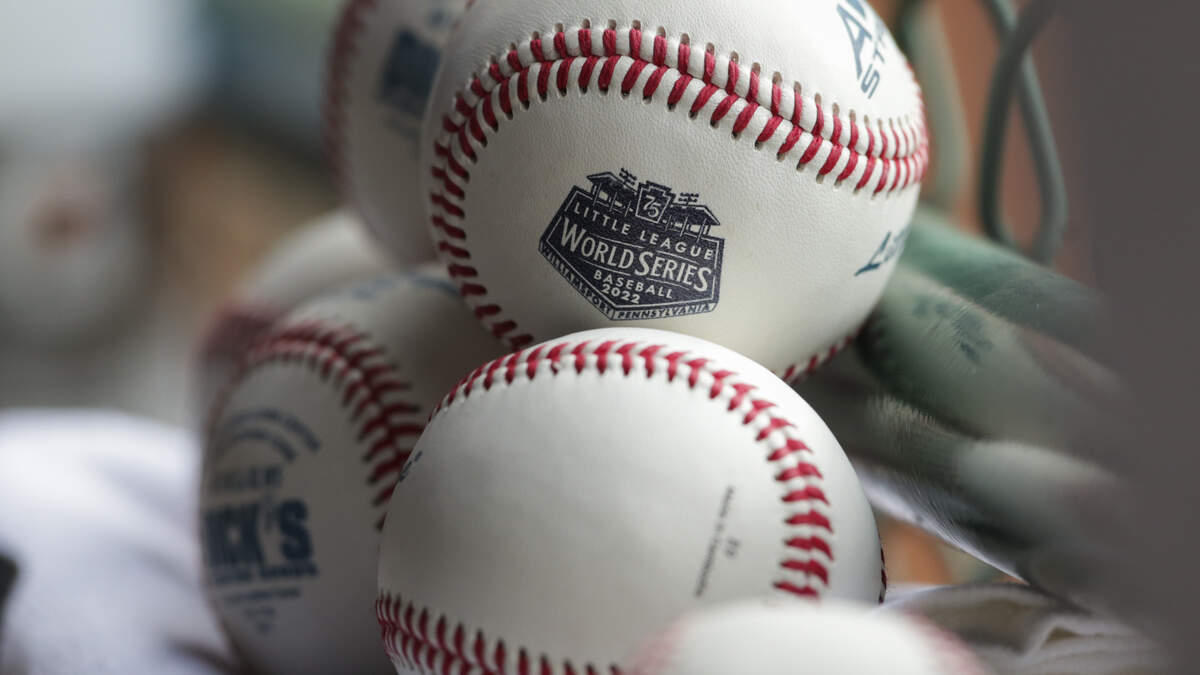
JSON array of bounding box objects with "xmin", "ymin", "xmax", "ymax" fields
[{"xmin": 538, "ymin": 169, "xmax": 725, "ymax": 321}]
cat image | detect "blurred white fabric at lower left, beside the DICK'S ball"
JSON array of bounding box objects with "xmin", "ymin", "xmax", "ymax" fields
[{"xmin": 0, "ymin": 411, "xmax": 235, "ymax": 675}]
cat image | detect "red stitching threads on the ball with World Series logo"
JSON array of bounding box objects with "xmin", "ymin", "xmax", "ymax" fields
[{"xmin": 432, "ymin": 24, "xmax": 929, "ymax": 357}]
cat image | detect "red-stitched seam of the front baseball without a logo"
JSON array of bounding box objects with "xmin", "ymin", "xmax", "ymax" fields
[{"xmin": 376, "ymin": 340, "xmax": 873, "ymax": 675}]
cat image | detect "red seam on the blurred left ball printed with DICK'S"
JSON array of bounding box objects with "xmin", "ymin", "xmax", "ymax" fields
[{"xmin": 212, "ymin": 321, "xmax": 425, "ymax": 527}]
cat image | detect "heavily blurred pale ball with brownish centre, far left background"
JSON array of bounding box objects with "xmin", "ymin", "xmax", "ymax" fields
[{"xmin": 0, "ymin": 147, "xmax": 152, "ymax": 350}]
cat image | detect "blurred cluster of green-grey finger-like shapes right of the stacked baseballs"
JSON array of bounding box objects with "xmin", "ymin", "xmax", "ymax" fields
[{"xmin": 797, "ymin": 220, "xmax": 1130, "ymax": 608}]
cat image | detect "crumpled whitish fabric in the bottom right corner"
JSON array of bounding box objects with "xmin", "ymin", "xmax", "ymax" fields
[{"xmin": 877, "ymin": 584, "xmax": 1165, "ymax": 675}]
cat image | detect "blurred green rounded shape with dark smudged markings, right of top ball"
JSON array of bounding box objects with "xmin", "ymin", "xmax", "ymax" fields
[{"xmin": 858, "ymin": 260, "xmax": 1118, "ymax": 447}]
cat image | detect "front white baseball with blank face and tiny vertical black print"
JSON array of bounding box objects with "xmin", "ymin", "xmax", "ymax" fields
[{"xmin": 377, "ymin": 328, "xmax": 882, "ymax": 674}]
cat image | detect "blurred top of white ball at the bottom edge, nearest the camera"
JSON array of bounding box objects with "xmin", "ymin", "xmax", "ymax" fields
[{"xmin": 628, "ymin": 599, "xmax": 985, "ymax": 675}]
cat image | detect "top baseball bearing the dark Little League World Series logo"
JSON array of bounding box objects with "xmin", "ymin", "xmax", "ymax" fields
[{"xmin": 421, "ymin": 0, "xmax": 929, "ymax": 380}]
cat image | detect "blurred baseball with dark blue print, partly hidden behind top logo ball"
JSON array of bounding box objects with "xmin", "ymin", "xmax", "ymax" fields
[{"xmin": 324, "ymin": 0, "xmax": 467, "ymax": 262}]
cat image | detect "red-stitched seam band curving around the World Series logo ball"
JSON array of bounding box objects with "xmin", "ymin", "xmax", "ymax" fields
[{"xmin": 430, "ymin": 22, "xmax": 929, "ymax": 357}]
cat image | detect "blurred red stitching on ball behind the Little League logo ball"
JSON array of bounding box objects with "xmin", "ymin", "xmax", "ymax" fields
[{"xmin": 322, "ymin": 0, "xmax": 379, "ymax": 198}]
